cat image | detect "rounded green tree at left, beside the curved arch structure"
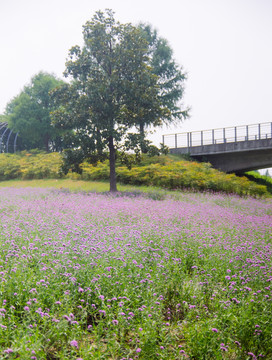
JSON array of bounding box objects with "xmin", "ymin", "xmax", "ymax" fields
[{"xmin": 5, "ymin": 72, "xmax": 64, "ymax": 151}]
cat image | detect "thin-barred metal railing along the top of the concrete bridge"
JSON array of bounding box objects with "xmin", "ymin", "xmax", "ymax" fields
[{"xmin": 162, "ymin": 122, "xmax": 272, "ymax": 149}]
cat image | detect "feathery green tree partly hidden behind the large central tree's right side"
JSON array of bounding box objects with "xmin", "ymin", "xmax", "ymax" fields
[{"xmin": 138, "ymin": 24, "xmax": 189, "ymax": 152}]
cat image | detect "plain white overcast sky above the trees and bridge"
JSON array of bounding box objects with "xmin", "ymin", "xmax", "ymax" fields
[{"xmin": 0, "ymin": 0, "xmax": 272, "ymax": 148}]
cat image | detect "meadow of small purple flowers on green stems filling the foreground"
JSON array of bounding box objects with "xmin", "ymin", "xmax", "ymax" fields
[{"xmin": 0, "ymin": 188, "xmax": 272, "ymax": 360}]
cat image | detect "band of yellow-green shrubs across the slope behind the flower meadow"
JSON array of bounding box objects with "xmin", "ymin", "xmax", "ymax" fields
[{"xmin": 0, "ymin": 151, "xmax": 269, "ymax": 196}]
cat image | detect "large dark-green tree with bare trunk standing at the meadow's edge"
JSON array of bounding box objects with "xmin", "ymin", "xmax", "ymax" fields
[{"xmin": 52, "ymin": 10, "xmax": 169, "ymax": 191}]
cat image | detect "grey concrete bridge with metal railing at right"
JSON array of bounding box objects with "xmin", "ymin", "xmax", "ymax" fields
[{"xmin": 162, "ymin": 122, "xmax": 272, "ymax": 173}]
